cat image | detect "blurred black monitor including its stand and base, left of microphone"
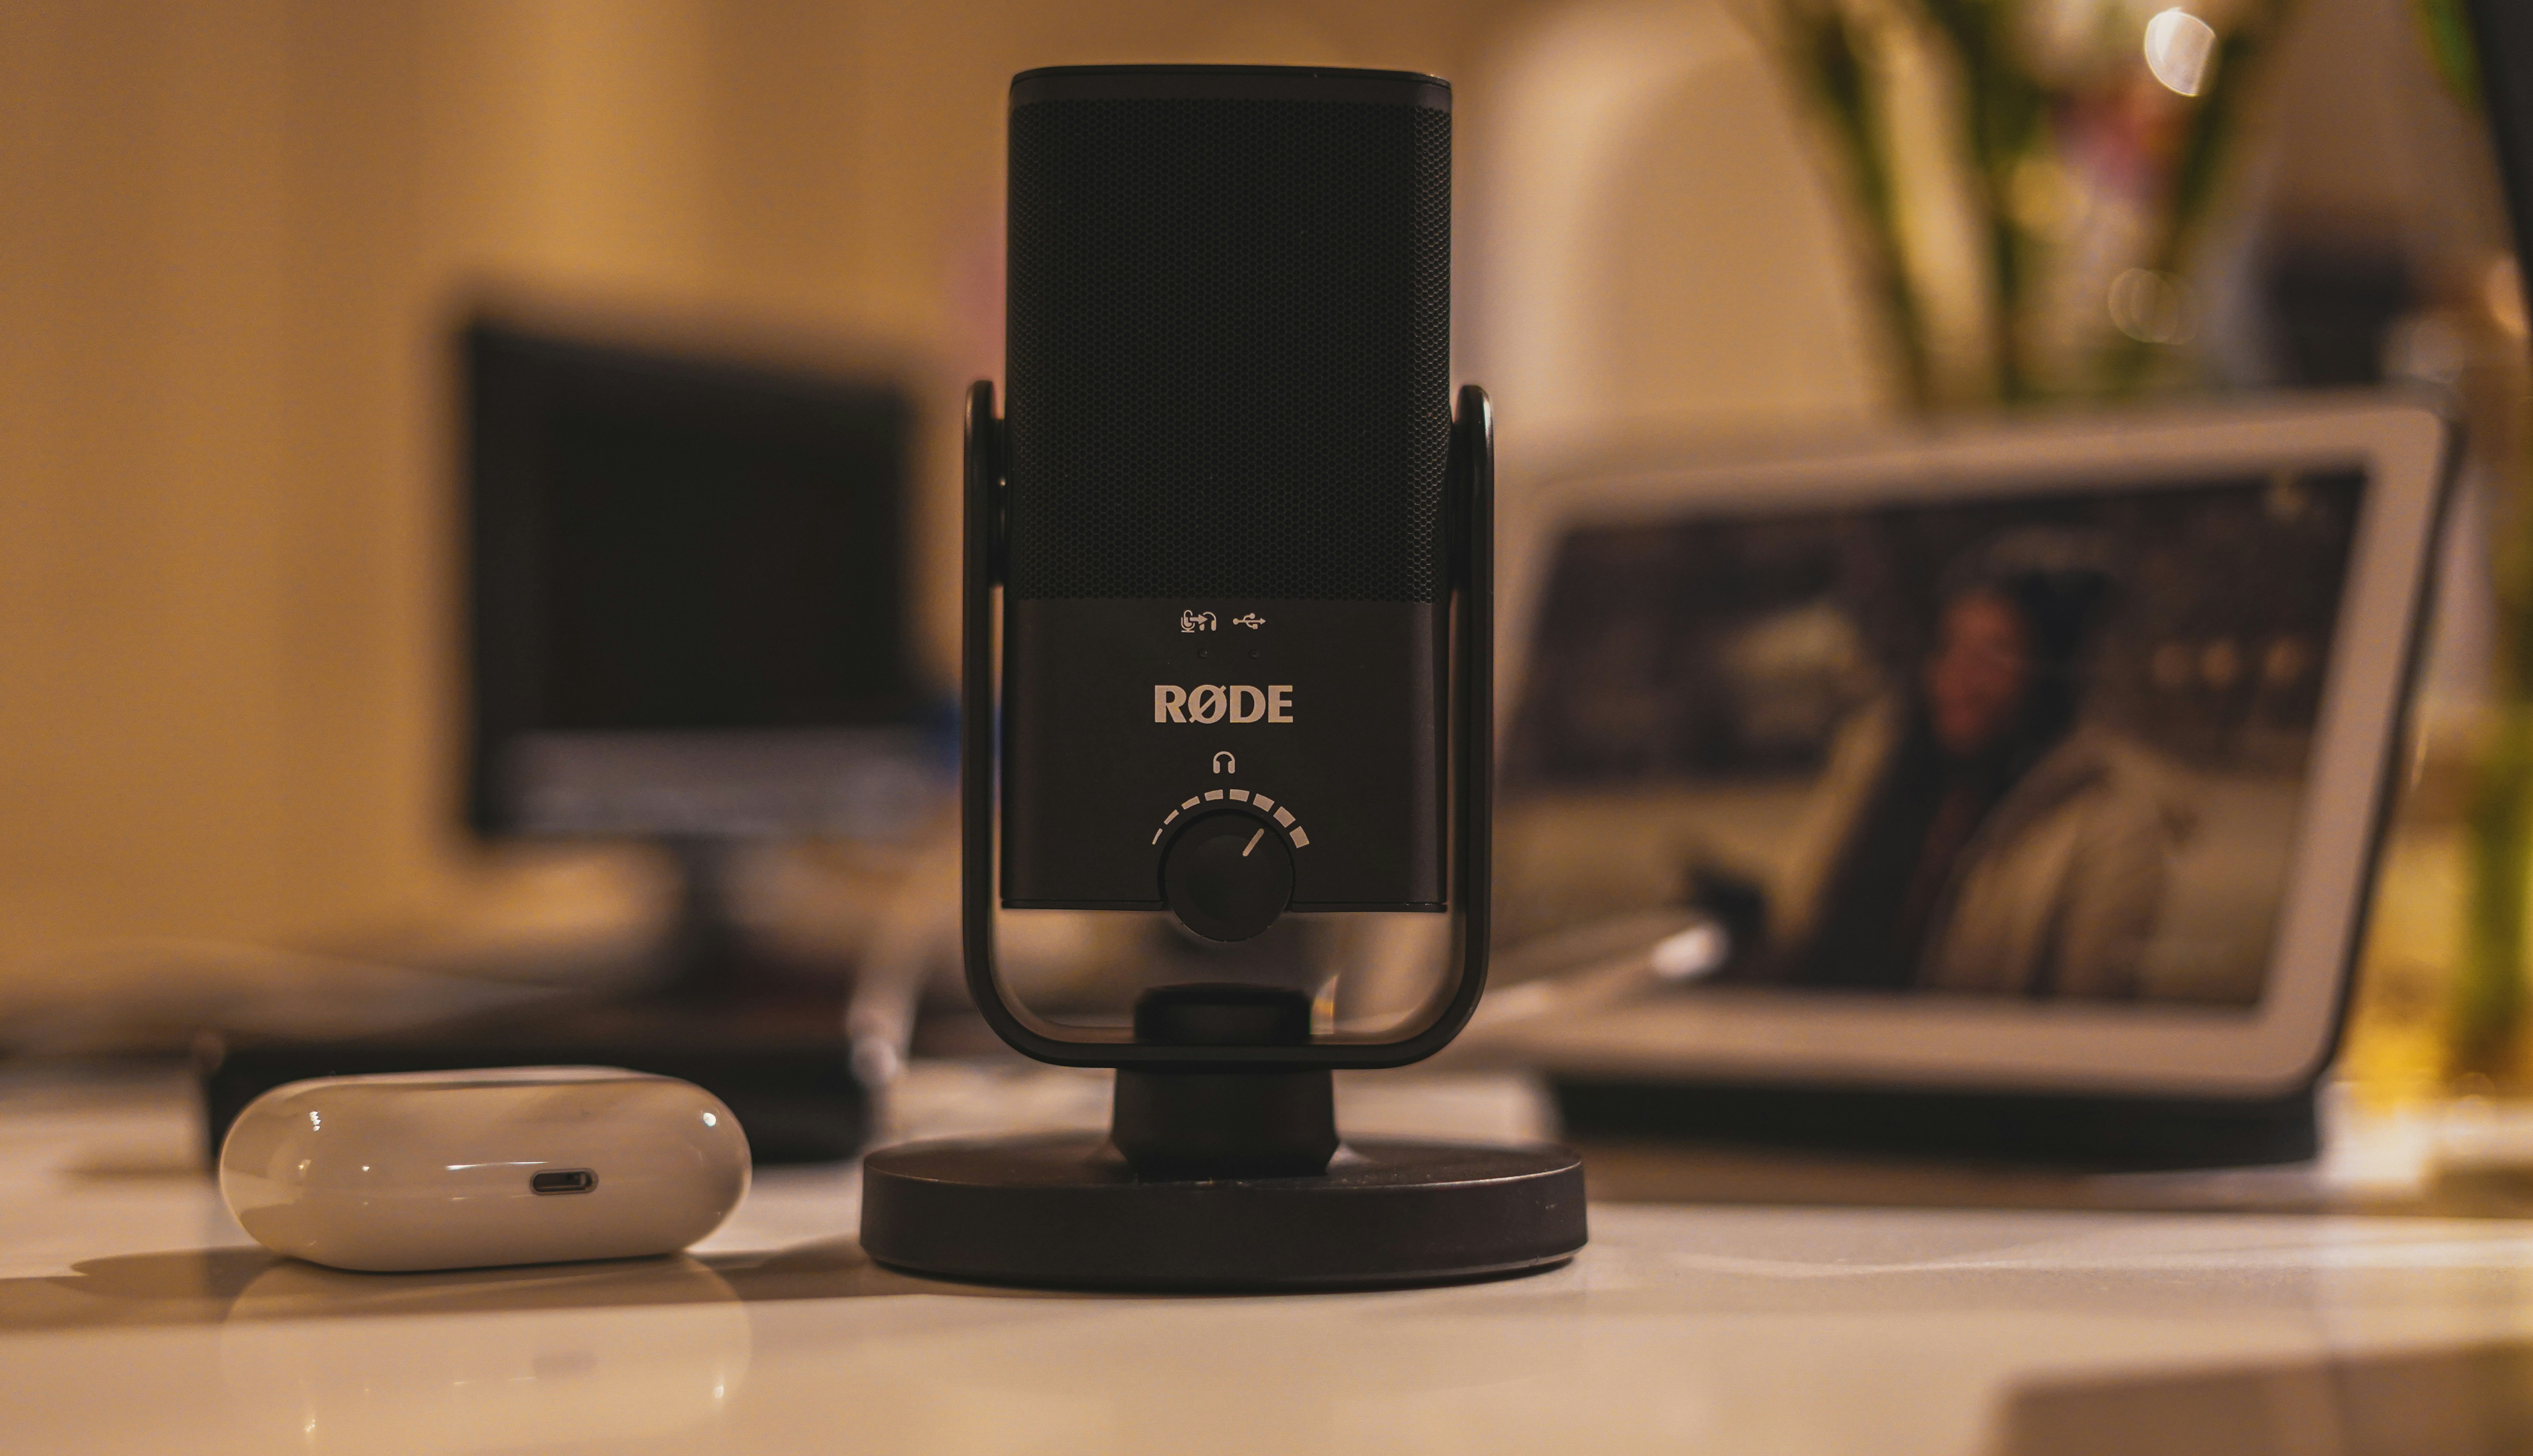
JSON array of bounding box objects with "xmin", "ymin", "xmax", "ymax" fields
[{"xmin": 198, "ymin": 319, "xmax": 950, "ymax": 1162}]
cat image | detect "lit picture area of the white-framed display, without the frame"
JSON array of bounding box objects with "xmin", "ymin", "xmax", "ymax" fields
[{"xmin": 1497, "ymin": 471, "xmax": 2366, "ymax": 1008}]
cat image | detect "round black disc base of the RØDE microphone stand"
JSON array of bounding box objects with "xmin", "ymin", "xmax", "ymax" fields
[{"xmin": 861, "ymin": 1135, "xmax": 1583, "ymax": 1291}]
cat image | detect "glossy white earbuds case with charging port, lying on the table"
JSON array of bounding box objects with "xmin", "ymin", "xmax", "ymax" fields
[{"xmin": 220, "ymin": 1066, "xmax": 747, "ymax": 1271}]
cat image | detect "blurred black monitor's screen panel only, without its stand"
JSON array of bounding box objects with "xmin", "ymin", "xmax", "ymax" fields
[{"xmin": 464, "ymin": 321, "xmax": 942, "ymax": 846}]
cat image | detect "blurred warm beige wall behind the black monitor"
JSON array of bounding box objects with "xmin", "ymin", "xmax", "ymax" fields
[{"xmin": 0, "ymin": 0, "xmax": 1505, "ymax": 982}]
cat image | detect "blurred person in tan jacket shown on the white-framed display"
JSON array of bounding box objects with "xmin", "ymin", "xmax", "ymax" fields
[{"xmin": 1763, "ymin": 532, "xmax": 2189, "ymax": 998}]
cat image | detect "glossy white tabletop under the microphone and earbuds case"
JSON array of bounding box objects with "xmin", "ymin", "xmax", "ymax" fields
[{"xmin": 0, "ymin": 1068, "xmax": 2533, "ymax": 1456}]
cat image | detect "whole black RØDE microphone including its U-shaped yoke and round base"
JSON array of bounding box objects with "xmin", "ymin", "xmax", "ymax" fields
[{"xmin": 861, "ymin": 66, "xmax": 1586, "ymax": 1289}]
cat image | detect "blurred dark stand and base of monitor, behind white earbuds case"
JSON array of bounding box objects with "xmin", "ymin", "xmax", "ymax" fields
[{"xmin": 195, "ymin": 838, "xmax": 871, "ymax": 1165}]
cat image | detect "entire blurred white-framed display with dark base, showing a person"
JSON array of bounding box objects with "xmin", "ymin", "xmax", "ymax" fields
[{"xmin": 1469, "ymin": 397, "xmax": 2449, "ymax": 1162}]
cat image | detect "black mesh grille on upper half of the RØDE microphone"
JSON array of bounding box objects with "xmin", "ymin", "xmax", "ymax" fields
[{"xmin": 1006, "ymin": 99, "xmax": 1451, "ymax": 600}]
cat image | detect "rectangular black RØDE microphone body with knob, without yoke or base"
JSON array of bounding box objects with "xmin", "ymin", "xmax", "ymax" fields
[{"xmin": 1001, "ymin": 66, "xmax": 1451, "ymax": 942}]
